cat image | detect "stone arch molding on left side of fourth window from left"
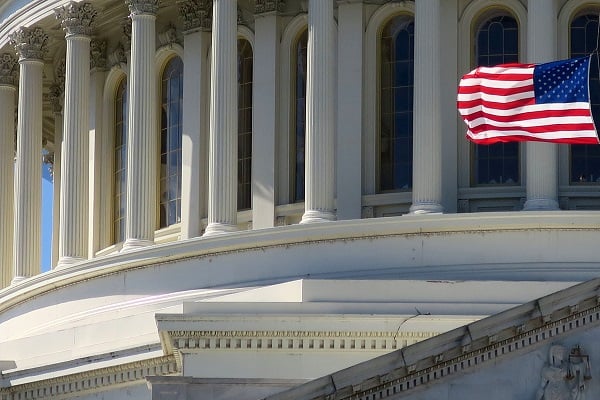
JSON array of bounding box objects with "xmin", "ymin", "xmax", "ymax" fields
[{"xmin": 276, "ymin": 14, "xmax": 308, "ymax": 204}]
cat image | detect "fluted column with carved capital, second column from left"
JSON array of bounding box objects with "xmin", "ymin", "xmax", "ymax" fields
[{"xmin": 11, "ymin": 28, "xmax": 48, "ymax": 284}]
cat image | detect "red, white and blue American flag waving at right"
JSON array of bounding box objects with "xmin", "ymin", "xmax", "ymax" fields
[{"xmin": 457, "ymin": 57, "xmax": 600, "ymax": 144}]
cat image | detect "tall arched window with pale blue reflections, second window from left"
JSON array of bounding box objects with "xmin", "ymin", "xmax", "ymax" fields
[{"xmin": 159, "ymin": 57, "xmax": 183, "ymax": 228}]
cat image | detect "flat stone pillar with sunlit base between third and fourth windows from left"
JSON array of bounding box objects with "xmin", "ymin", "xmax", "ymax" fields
[{"xmin": 252, "ymin": 0, "xmax": 284, "ymax": 229}]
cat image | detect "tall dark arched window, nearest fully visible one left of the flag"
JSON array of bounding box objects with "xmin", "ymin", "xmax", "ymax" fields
[{"xmin": 378, "ymin": 15, "xmax": 415, "ymax": 192}]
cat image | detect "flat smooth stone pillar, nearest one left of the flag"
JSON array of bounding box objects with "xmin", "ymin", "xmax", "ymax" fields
[{"xmin": 336, "ymin": 0, "xmax": 365, "ymax": 220}]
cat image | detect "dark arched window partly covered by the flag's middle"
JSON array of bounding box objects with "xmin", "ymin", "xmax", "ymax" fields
[{"xmin": 471, "ymin": 15, "xmax": 521, "ymax": 185}]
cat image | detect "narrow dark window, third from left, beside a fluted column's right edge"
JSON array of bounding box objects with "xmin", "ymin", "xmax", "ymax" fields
[{"xmin": 237, "ymin": 39, "xmax": 253, "ymax": 210}]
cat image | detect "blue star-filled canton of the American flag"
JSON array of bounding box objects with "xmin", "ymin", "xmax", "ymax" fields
[{"xmin": 533, "ymin": 57, "xmax": 590, "ymax": 104}]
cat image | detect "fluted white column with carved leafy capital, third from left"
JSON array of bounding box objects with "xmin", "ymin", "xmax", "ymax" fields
[{"xmin": 55, "ymin": 2, "xmax": 97, "ymax": 268}]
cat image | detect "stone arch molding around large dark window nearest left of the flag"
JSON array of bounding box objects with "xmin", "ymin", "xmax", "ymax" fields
[{"xmin": 362, "ymin": 2, "xmax": 415, "ymax": 196}]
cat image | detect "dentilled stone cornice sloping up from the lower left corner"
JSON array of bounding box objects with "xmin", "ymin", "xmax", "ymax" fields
[{"xmin": 0, "ymin": 356, "xmax": 178, "ymax": 399}]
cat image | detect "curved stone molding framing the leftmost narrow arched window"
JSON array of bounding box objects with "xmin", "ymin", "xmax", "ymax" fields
[{"xmin": 97, "ymin": 66, "xmax": 128, "ymax": 249}]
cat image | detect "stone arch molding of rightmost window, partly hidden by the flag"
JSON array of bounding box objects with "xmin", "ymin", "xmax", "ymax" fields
[{"xmin": 557, "ymin": 0, "xmax": 600, "ymax": 188}]
